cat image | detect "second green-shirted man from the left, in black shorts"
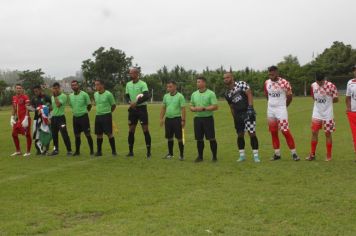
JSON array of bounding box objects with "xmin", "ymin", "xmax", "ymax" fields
[{"xmin": 69, "ymin": 80, "xmax": 94, "ymax": 156}]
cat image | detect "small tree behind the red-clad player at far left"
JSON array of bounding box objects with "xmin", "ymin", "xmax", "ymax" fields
[{"xmin": 18, "ymin": 69, "xmax": 44, "ymax": 94}]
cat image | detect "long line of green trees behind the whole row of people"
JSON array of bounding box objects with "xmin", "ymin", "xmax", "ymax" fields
[{"xmin": 0, "ymin": 41, "xmax": 356, "ymax": 105}]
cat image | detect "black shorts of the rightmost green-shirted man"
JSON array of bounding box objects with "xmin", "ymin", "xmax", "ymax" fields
[{"xmin": 194, "ymin": 116, "xmax": 215, "ymax": 140}]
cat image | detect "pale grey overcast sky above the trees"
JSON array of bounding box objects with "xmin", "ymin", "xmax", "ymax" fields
[{"xmin": 0, "ymin": 0, "xmax": 356, "ymax": 79}]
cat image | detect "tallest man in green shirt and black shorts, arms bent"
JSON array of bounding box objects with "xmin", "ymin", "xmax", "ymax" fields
[{"xmin": 125, "ymin": 68, "xmax": 151, "ymax": 159}]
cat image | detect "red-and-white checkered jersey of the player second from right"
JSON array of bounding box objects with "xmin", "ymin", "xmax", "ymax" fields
[{"xmin": 310, "ymin": 81, "xmax": 338, "ymax": 121}]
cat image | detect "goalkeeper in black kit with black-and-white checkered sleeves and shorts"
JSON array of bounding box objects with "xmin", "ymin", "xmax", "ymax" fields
[{"xmin": 224, "ymin": 73, "xmax": 260, "ymax": 162}]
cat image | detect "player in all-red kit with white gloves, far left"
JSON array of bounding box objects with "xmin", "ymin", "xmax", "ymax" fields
[{"xmin": 10, "ymin": 84, "xmax": 32, "ymax": 157}]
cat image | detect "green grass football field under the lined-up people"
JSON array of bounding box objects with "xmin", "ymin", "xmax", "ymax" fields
[{"xmin": 0, "ymin": 98, "xmax": 356, "ymax": 235}]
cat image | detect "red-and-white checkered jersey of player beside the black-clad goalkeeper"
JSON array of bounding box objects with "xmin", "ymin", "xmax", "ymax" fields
[{"xmin": 264, "ymin": 77, "xmax": 292, "ymax": 107}]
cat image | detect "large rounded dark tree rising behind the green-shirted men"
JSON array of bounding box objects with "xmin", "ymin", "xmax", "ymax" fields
[{"xmin": 82, "ymin": 47, "xmax": 133, "ymax": 94}]
